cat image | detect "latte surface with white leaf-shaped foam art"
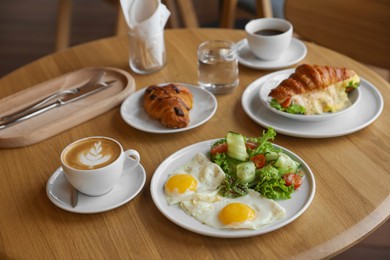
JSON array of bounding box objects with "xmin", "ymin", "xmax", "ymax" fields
[{"xmin": 63, "ymin": 138, "xmax": 121, "ymax": 170}]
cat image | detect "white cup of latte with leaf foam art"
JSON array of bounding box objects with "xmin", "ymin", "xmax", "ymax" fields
[{"xmin": 61, "ymin": 136, "xmax": 140, "ymax": 196}]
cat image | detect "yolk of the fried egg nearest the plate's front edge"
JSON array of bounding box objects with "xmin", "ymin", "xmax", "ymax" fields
[{"xmin": 218, "ymin": 203, "xmax": 256, "ymax": 225}]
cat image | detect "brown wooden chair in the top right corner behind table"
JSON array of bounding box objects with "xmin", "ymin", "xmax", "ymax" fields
[{"xmin": 284, "ymin": 0, "xmax": 390, "ymax": 75}]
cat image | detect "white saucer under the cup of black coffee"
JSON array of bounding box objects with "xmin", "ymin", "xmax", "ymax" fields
[{"xmin": 237, "ymin": 38, "xmax": 307, "ymax": 70}]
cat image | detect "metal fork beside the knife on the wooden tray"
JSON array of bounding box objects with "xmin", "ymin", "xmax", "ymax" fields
[{"xmin": 0, "ymin": 71, "xmax": 105, "ymax": 121}]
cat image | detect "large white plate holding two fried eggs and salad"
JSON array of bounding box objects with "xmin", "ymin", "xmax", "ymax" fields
[{"xmin": 150, "ymin": 139, "xmax": 316, "ymax": 238}]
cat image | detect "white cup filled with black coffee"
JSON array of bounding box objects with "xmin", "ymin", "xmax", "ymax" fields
[{"xmin": 245, "ymin": 18, "xmax": 293, "ymax": 60}]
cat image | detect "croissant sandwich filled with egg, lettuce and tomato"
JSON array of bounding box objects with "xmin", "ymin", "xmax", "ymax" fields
[{"xmin": 269, "ymin": 64, "xmax": 360, "ymax": 115}]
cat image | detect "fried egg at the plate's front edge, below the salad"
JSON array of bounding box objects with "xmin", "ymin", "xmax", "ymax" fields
[{"xmin": 180, "ymin": 190, "xmax": 286, "ymax": 229}]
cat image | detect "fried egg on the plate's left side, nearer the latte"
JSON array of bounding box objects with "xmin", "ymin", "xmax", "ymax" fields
[{"xmin": 164, "ymin": 153, "xmax": 225, "ymax": 205}]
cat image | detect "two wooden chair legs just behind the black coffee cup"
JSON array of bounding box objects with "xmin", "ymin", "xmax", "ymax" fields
[{"xmin": 220, "ymin": 0, "xmax": 273, "ymax": 28}]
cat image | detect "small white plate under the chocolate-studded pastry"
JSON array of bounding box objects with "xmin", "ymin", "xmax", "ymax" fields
[{"xmin": 121, "ymin": 83, "xmax": 217, "ymax": 134}]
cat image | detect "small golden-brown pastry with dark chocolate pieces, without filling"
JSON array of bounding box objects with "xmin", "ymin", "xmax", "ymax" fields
[{"xmin": 144, "ymin": 84, "xmax": 193, "ymax": 128}]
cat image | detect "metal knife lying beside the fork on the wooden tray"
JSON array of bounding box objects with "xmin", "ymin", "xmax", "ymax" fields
[{"xmin": 0, "ymin": 80, "xmax": 116, "ymax": 130}]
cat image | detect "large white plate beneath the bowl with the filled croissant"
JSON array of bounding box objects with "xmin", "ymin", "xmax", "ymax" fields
[{"xmin": 241, "ymin": 72, "xmax": 383, "ymax": 138}]
